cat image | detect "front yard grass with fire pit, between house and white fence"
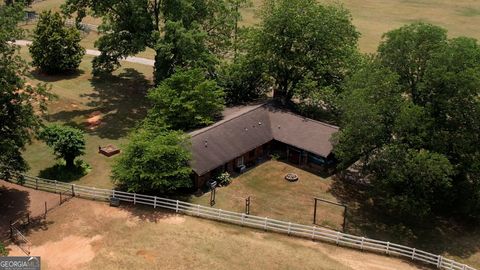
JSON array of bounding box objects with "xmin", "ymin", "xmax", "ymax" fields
[{"xmin": 188, "ymin": 161, "xmax": 343, "ymax": 230}]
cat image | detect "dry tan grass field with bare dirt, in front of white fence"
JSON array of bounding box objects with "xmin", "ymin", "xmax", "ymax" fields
[{"xmin": 9, "ymin": 196, "xmax": 419, "ymax": 270}]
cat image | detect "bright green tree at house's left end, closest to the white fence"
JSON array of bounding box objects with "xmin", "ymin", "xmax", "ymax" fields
[{"xmin": 112, "ymin": 121, "xmax": 193, "ymax": 193}]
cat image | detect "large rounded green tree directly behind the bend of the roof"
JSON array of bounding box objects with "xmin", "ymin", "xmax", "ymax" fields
[{"xmin": 239, "ymin": 0, "xmax": 359, "ymax": 106}]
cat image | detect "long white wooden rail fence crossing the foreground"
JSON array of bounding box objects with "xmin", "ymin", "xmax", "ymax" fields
[{"xmin": 15, "ymin": 176, "xmax": 475, "ymax": 270}]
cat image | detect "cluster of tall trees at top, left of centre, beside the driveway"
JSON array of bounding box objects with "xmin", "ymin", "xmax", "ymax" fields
[{"xmin": 64, "ymin": 0, "xmax": 244, "ymax": 82}]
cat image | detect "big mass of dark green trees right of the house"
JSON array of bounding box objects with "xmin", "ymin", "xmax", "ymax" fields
[{"xmin": 334, "ymin": 24, "xmax": 480, "ymax": 221}]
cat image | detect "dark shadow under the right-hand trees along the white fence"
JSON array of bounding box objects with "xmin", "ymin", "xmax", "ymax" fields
[{"xmin": 329, "ymin": 174, "xmax": 480, "ymax": 259}]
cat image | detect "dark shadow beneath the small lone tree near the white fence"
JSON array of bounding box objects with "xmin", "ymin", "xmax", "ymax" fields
[{"xmin": 38, "ymin": 160, "xmax": 91, "ymax": 182}]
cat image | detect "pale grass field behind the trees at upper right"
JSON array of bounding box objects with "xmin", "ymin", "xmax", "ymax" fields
[{"xmin": 244, "ymin": 0, "xmax": 480, "ymax": 52}]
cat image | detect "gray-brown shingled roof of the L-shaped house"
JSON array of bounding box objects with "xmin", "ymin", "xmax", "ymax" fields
[{"xmin": 190, "ymin": 104, "xmax": 338, "ymax": 175}]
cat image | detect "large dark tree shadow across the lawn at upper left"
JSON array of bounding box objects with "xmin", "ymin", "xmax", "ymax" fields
[{"xmin": 49, "ymin": 68, "xmax": 151, "ymax": 139}]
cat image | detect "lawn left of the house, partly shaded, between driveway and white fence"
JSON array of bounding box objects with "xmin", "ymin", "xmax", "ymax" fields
[{"xmin": 21, "ymin": 48, "xmax": 153, "ymax": 188}]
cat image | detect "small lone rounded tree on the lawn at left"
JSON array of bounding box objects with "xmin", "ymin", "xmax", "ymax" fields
[{"xmin": 39, "ymin": 125, "xmax": 85, "ymax": 168}]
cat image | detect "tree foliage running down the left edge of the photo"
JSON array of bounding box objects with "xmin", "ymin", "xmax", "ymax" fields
[{"xmin": 0, "ymin": 3, "xmax": 50, "ymax": 178}]
